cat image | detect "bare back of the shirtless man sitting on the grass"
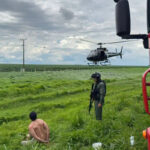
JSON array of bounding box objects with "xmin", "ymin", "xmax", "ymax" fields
[{"xmin": 29, "ymin": 112, "xmax": 49, "ymax": 143}]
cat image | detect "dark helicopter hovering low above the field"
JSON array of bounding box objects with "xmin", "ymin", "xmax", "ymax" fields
[{"xmin": 80, "ymin": 39, "xmax": 135, "ymax": 65}]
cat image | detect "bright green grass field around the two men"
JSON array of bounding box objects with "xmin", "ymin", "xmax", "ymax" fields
[{"xmin": 0, "ymin": 67, "xmax": 150, "ymax": 150}]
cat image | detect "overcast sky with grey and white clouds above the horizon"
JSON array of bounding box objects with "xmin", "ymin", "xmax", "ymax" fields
[{"xmin": 0, "ymin": 0, "xmax": 148, "ymax": 65}]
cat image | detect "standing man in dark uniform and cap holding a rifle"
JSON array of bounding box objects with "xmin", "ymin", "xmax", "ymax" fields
[{"xmin": 91, "ymin": 73, "xmax": 106, "ymax": 120}]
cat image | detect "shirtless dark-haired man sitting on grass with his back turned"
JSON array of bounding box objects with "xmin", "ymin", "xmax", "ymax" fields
[{"xmin": 21, "ymin": 112, "xmax": 49, "ymax": 145}]
